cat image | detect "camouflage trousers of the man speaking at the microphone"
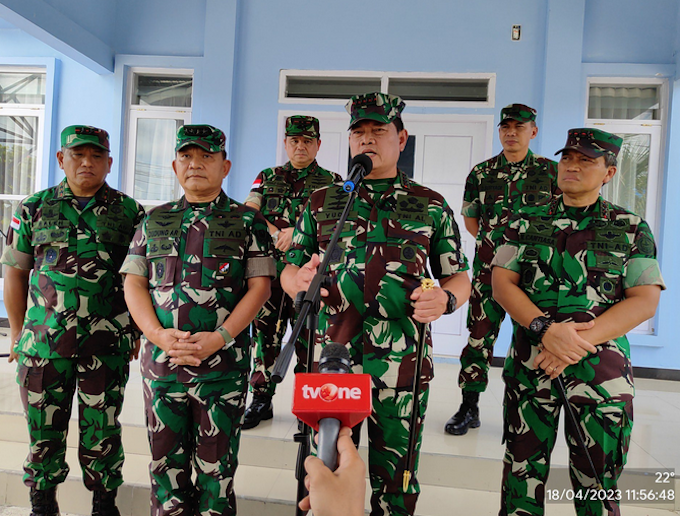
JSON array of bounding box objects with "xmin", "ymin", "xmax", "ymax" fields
[{"xmin": 352, "ymin": 384, "xmax": 430, "ymax": 516}]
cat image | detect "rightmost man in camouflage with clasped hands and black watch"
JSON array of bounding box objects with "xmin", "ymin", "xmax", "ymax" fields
[{"xmin": 492, "ymin": 129, "xmax": 665, "ymax": 516}]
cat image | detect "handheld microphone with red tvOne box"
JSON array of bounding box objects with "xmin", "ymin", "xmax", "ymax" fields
[{"xmin": 293, "ymin": 342, "xmax": 371, "ymax": 471}]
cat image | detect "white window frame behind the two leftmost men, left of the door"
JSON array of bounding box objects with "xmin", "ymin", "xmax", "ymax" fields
[{"xmin": 122, "ymin": 67, "xmax": 195, "ymax": 206}]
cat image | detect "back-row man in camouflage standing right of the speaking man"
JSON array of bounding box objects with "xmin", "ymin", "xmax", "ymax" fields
[{"xmin": 444, "ymin": 104, "xmax": 557, "ymax": 435}]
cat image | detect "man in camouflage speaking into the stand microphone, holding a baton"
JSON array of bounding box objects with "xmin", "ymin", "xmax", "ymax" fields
[{"xmin": 281, "ymin": 93, "xmax": 470, "ymax": 515}]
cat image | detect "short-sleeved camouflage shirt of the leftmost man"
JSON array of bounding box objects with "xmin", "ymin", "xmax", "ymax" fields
[{"xmin": 0, "ymin": 179, "xmax": 144, "ymax": 359}]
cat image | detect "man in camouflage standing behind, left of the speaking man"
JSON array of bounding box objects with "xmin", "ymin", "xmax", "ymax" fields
[{"xmin": 243, "ymin": 115, "xmax": 341, "ymax": 430}]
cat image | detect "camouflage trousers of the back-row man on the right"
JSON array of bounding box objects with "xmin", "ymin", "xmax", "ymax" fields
[{"xmin": 458, "ymin": 266, "xmax": 505, "ymax": 392}]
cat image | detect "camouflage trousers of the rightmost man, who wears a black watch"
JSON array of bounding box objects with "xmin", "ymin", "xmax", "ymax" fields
[{"xmin": 499, "ymin": 371, "xmax": 633, "ymax": 516}]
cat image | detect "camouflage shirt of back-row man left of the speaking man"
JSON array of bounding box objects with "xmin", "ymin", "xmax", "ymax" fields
[{"xmin": 245, "ymin": 160, "xmax": 342, "ymax": 274}]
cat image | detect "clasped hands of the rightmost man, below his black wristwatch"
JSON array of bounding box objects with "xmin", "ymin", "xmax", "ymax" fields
[{"xmin": 534, "ymin": 321, "xmax": 597, "ymax": 379}]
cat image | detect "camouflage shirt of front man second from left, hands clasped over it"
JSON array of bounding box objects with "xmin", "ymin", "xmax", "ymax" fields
[{"xmin": 121, "ymin": 192, "xmax": 274, "ymax": 383}]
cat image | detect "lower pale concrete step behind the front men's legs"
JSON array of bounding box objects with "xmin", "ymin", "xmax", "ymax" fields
[{"xmin": 0, "ymin": 413, "xmax": 680, "ymax": 516}]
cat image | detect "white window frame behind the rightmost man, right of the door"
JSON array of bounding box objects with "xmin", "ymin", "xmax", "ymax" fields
[{"xmin": 585, "ymin": 77, "xmax": 669, "ymax": 335}]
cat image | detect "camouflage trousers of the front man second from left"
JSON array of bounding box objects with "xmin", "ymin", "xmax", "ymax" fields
[{"xmin": 144, "ymin": 376, "xmax": 247, "ymax": 516}]
